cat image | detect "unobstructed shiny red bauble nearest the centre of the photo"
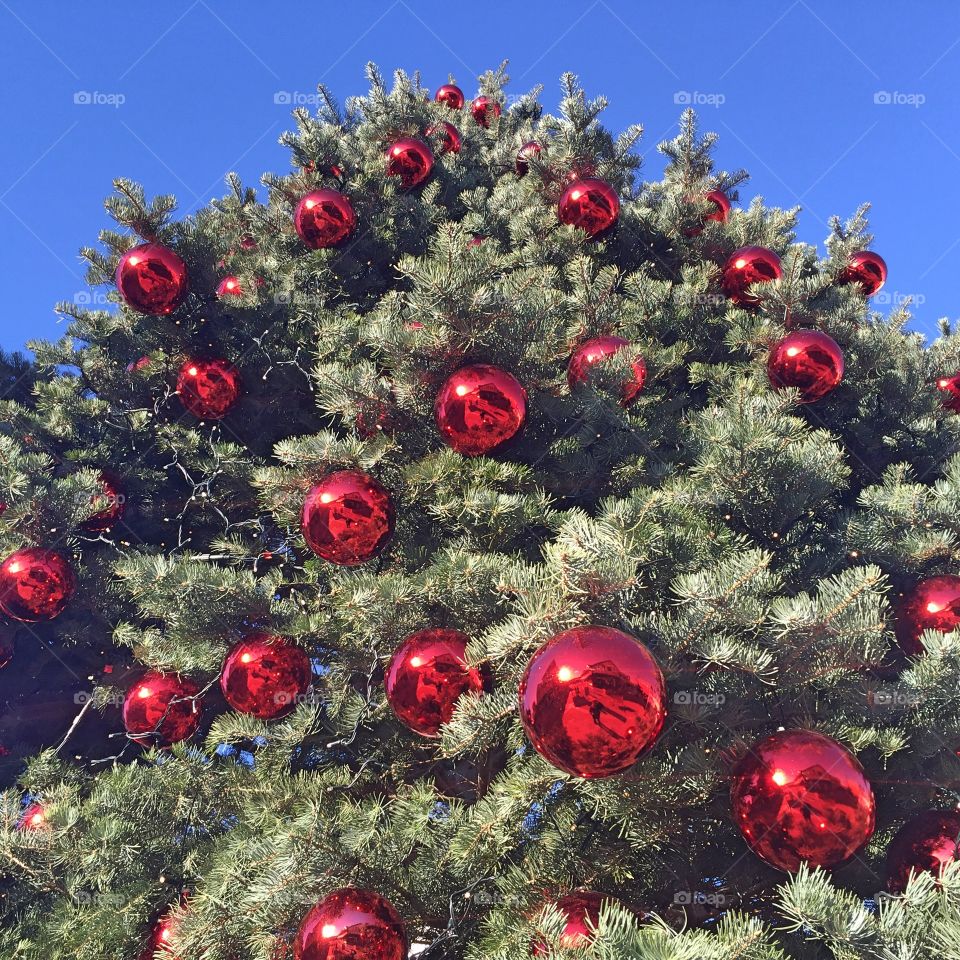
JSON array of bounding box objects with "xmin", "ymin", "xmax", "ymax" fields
[{"xmin": 433, "ymin": 363, "xmax": 527, "ymax": 457}]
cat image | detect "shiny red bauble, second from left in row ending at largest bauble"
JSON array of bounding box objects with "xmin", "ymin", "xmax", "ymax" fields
[{"xmin": 220, "ymin": 633, "xmax": 313, "ymax": 720}]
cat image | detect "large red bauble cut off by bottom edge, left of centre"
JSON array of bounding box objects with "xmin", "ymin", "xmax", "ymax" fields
[{"xmin": 293, "ymin": 887, "xmax": 407, "ymax": 960}]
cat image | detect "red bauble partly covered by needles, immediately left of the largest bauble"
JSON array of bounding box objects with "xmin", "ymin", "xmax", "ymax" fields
[{"xmin": 384, "ymin": 630, "xmax": 483, "ymax": 737}]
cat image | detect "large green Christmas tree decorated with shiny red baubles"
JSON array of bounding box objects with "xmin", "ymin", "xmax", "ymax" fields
[{"xmin": 0, "ymin": 68, "xmax": 960, "ymax": 960}]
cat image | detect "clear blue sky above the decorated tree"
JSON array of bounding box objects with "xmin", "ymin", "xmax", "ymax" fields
[{"xmin": 0, "ymin": 0, "xmax": 960, "ymax": 349}]
